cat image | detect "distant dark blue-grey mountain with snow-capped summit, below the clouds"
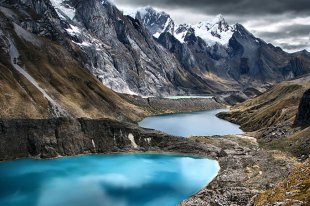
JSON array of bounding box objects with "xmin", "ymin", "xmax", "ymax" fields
[{"xmin": 130, "ymin": 7, "xmax": 310, "ymax": 90}]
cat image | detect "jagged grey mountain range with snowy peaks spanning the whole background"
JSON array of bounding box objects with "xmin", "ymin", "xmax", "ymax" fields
[{"xmin": 0, "ymin": 0, "xmax": 310, "ymax": 100}]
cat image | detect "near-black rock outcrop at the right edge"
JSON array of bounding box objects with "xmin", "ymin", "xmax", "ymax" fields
[{"xmin": 295, "ymin": 89, "xmax": 310, "ymax": 125}]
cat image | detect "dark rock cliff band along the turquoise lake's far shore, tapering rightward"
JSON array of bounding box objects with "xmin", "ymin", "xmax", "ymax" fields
[{"xmin": 0, "ymin": 118, "xmax": 220, "ymax": 160}]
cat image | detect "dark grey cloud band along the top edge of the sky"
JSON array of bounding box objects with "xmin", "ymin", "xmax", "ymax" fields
[{"xmin": 115, "ymin": 0, "xmax": 310, "ymax": 15}]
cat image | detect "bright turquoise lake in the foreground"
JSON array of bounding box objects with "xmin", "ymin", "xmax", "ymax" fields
[{"xmin": 0, "ymin": 154, "xmax": 219, "ymax": 206}]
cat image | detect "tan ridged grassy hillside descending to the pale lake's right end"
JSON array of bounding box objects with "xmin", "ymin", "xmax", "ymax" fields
[{"xmin": 220, "ymin": 77, "xmax": 310, "ymax": 132}]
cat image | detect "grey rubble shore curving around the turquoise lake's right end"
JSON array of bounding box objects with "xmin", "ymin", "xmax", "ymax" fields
[{"xmin": 180, "ymin": 136, "xmax": 296, "ymax": 206}]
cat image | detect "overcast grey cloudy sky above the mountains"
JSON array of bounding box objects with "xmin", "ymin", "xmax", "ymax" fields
[{"xmin": 113, "ymin": 0, "xmax": 310, "ymax": 52}]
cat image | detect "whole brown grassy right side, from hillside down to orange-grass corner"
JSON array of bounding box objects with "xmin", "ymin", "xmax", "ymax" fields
[{"xmin": 219, "ymin": 76, "xmax": 310, "ymax": 206}]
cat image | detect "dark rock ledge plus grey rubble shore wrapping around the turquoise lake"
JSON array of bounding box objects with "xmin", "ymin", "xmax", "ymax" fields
[{"xmin": 0, "ymin": 118, "xmax": 294, "ymax": 205}]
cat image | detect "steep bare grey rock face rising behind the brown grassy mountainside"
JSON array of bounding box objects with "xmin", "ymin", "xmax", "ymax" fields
[{"xmin": 48, "ymin": 0, "xmax": 220, "ymax": 95}]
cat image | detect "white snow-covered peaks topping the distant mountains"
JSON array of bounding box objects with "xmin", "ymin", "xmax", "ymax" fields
[{"xmin": 127, "ymin": 6, "xmax": 235, "ymax": 46}]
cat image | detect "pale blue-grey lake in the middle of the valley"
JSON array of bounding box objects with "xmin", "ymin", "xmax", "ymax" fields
[{"xmin": 139, "ymin": 109, "xmax": 243, "ymax": 137}]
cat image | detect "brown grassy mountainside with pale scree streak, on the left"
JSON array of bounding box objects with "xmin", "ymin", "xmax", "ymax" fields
[{"xmin": 0, "ymin": 1, "xmax": 148, "ymax": 120}]
